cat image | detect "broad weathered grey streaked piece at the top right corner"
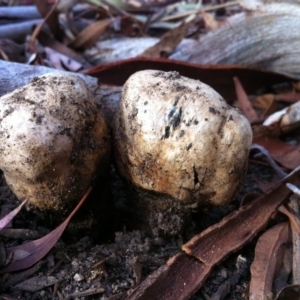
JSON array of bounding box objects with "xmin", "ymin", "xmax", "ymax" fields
[{"xmin": 170, "ymin": 3, "xmax": 300, "ymax": 78}]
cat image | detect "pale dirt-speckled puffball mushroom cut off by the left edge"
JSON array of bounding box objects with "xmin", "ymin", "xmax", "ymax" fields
[{"xmin": 0, "ymin": 73, "xmax": 110, "ymax": 209}]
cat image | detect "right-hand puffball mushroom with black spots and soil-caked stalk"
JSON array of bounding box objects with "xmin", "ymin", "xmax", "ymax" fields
[{"xmin": 114, "ymin": 70, "xmax": 252, "ymax": 235}]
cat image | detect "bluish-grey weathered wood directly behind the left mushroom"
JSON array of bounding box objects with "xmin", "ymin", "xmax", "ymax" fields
[{"xmin": 0, "ymin": 60, "xmax": 121, "ymax": 123}]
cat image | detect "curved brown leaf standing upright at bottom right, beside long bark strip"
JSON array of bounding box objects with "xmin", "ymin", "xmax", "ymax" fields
[{"xmin": 249, "ymin": 222, "xmax": 289, "ymax": 300}]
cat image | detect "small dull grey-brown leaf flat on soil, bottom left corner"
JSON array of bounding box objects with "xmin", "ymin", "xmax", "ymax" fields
[{"xmin": 14, "ymin": 276, "xmax": 58, "ymax": 292}]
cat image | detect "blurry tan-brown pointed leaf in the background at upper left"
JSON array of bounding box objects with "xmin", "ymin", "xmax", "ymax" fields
[{"xmin": 69, "ymin": 19, "xmax": 114, "ymax": 49}]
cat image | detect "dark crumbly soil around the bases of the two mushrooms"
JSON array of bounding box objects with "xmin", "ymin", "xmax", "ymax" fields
[{"xmin": 0, "ymin": 159, "xmax": 271, "ymax": 300}]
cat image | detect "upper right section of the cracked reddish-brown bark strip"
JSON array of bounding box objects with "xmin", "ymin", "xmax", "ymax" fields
[{"xmin": 182, "ymin": 167, "xmax": 300, "ymax": 265}]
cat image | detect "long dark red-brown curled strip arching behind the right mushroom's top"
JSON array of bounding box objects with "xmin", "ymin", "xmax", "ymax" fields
[{"xmin": 84, "ymin": 57, "xmax": 291, "ymax": 103}]
